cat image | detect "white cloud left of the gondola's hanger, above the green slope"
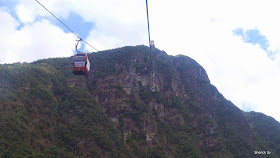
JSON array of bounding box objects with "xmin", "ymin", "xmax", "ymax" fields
[{"xmin": 0, "ymin": 11, "xmax": 75, "ymax": 63}]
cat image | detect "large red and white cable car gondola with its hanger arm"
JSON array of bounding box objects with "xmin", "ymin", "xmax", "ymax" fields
[{"xmin": 73, "ymin": 39, "xmax": 90, "ymax": 75}]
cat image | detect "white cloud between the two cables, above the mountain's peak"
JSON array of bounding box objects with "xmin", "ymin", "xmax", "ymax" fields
[{"xmin": 12, "ymin": 0, "xmax": 148, "ymax": 51}]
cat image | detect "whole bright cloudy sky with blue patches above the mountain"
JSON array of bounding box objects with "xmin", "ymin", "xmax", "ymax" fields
[{"xmin": 0, "ymin": 0, "xmax": 280, "ymax": 121}]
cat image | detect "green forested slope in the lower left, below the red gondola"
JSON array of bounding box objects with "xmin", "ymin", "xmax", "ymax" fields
[{"xmin": 0, "ymin": 59, "xmax": 132, "ymax": 157}]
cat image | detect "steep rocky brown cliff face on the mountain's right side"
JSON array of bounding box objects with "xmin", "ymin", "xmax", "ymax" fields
[{"xmin": 85, "ymin": 46, "xmax": 254, "ymax": 157}]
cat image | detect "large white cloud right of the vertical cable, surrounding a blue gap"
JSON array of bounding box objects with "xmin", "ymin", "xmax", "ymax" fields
[{"xmin": 145, "ymin": 0, "xmax": 280, "ymax": 121}]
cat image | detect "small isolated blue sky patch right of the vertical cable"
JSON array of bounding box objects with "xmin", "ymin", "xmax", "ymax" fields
[{"xmin": 232, "ymin": 28, "xmax": 269, "ymax": 51}]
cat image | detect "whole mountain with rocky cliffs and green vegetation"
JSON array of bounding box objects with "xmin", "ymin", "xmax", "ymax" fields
[{"xmin": 0, "ymin": 46, "xmax": 280, "ymax": 158}]
